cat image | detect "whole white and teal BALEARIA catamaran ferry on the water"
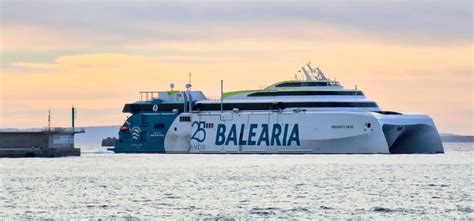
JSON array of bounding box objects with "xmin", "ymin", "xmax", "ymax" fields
[{"xmin": 111, "ymin": 64, "xmax": 444, "ymax": 154}]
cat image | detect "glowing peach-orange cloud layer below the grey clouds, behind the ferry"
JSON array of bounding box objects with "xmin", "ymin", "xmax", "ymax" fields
[{"xmin": 0, "ymin": 39, "xmax": 474, "ymax": 134}]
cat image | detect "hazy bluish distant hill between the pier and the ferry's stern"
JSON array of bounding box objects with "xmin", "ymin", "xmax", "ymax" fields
[{"xmin": 75, "ymin": 126, "xmax": 120, "ymax": 145}]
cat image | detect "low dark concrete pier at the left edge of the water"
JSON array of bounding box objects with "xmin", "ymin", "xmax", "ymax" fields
[{"xmin": 0, "ymin": 128, "xmax": 85, "ymax": 157}]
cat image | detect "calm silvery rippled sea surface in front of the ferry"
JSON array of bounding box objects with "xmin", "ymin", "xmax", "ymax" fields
[{"xmin": 0, "ymin": 143, "xmax": 474, "ymax": 220}]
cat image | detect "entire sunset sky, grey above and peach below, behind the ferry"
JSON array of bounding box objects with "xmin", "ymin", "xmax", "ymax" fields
[{"xmin": 0, "ymin": 0, "xmax": 474, "ymax": 134}]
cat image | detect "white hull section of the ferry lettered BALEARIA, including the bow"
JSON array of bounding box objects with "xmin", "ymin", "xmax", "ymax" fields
[{"xmin": 164, "ymin": 110, "xmax": 443, "ymax": 154}]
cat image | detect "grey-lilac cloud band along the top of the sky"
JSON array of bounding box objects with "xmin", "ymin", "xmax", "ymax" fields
[{"xmin": 1, "ymin": 0, "xmax": 472, "ymax": 47}]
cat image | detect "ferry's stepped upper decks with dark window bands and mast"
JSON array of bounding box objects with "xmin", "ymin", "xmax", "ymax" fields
[{"xmin": 123, "ymin": 64, "xmax": 379, "ymax": 113}]
